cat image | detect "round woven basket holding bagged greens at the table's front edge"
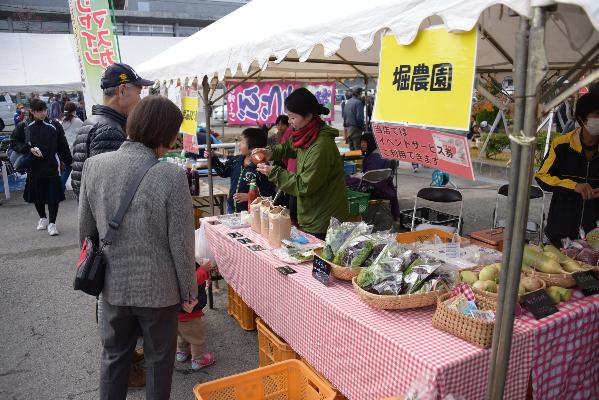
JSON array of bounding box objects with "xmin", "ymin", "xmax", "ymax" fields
[{"xmin": 352, "ymin": 278, "xmax": 447, "ymax": 310}]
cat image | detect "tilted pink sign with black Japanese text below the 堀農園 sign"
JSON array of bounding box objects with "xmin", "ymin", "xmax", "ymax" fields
[{"xmin": 372, "ymin": 122, "xmax": 474, "ymax": 180}]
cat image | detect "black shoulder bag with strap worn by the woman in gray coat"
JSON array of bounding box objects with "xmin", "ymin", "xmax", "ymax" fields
[{"xmin": 73, "ymin": 159, "xmax": 158, "ymax": 296}]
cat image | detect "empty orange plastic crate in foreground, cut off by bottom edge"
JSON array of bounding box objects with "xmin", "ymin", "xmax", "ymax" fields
[{"xmin": 193, "ymin": 360, "xmax": 335, "ymax": 400}]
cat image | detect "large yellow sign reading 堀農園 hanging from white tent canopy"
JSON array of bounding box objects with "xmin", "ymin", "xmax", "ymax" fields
[{"xmin": 372, "ymin": 28, "xmax": 476, "ymax": 130}]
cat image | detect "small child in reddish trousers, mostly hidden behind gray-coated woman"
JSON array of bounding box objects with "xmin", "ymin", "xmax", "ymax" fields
[{"xmin": 176, "ymin": 260, "xmax": 216, "ymax": 371}]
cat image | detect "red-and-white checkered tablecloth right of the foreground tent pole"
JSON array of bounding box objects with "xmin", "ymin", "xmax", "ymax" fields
[{"xmin": 518, "ymin": 290, "xmax": 599, "ymax": 400}]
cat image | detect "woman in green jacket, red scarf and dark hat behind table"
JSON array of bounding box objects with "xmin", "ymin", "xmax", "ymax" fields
[{"xmin": 253, "ymin": 88, "xmax": 348, "ymax": 239}]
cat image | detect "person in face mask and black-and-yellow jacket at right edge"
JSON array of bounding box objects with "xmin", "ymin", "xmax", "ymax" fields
[{"xmin": 535, "ymin": 93, "xmax": 599, "ymax": 247}]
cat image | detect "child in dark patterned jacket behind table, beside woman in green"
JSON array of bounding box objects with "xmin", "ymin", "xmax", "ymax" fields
[{"xmin": 204, "ymin": 128, "xmax": 275, "ymax": 214}]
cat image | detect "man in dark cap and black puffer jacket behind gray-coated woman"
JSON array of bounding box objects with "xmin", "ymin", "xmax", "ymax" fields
[{"xmin": 71, "ymin": 63, "xmax": 154, "ymax": 197}]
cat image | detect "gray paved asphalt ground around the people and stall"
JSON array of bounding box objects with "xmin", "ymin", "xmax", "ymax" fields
[{"xmin": 0, "ymin": 164, "xmax": 548, "ymax": 400}]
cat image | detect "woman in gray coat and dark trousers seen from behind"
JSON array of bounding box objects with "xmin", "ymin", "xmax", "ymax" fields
[{"xmin": 79, "ymin": 96, "xmax": 197, "ymax": 400}]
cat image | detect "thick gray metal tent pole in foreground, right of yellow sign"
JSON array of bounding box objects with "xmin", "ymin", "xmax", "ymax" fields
[{"xmin": 488, "ymin": 7, "xmax": 548, "ymax": 400}]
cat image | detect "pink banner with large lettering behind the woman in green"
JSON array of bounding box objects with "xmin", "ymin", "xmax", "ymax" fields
[{"xmin": 226, "ymin": 81, "xmax": 336, "ymax": 125}]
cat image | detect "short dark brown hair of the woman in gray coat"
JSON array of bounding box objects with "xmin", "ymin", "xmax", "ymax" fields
[{"xmin": 127, "ymin": 96, "xmax": 183, "ymax": 149}]
